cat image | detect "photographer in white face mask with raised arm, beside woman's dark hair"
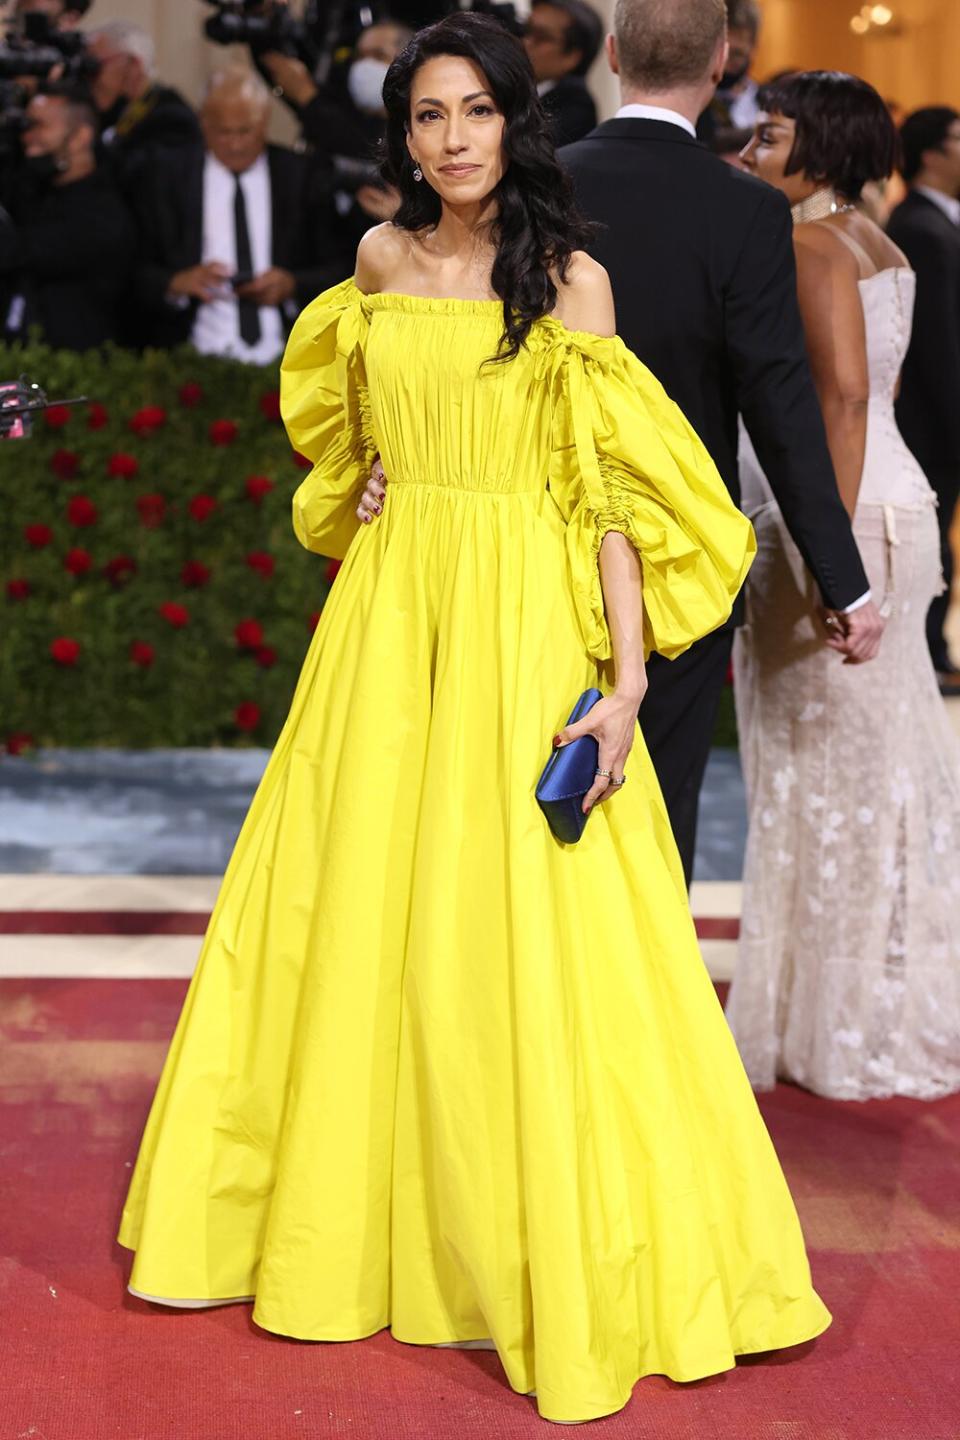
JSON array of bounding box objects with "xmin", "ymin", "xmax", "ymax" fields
[{"xmin": 261, "ymin": 20, "xmax": 412, "ymax": 251}]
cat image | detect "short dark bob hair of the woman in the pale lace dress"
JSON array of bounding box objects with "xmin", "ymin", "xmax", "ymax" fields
[{"xmin": 757, "ymin": 71, "xmax": 897, "ymax": 200}]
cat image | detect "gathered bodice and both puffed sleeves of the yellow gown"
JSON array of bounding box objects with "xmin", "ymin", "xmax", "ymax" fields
[{"xmin": 281, "ymin": 281, "xmax": 754, "ymax": 660}]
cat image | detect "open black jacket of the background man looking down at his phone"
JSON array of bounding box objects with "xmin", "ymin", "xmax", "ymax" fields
[{"xmin": 135, "ymin": 145, "xmax": 351, "ymax": 346}]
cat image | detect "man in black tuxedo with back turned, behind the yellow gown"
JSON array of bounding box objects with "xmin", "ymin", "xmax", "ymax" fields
[{"xmin": 560, "ymin": 0, "xmax": 882, "ymax": 881}]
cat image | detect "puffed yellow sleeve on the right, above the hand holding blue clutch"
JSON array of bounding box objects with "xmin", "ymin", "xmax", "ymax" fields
[{"xmin": 550, "ymin": 331, "xmax": 756, "ymax": 661}]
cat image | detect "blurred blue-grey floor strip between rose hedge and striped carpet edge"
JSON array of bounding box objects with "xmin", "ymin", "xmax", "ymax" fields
[{"xmin": 0, "ymin": 750, "xmax": 746, "ymax": 880}]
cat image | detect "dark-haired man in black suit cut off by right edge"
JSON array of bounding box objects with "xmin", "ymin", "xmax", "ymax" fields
[{"xmin": 888, "ymin": 105, "xmax": 960, "ymax": 679}]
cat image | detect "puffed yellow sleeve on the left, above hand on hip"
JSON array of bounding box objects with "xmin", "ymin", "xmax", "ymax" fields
[{"xmin": 281, "ymin": 279, "xmax": 377, "ymax": 560}]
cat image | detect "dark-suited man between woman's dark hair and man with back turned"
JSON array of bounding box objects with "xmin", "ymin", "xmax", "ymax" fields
[{"xmin": 524, "ymin": 0, "xmax": 603, "ymax": 145}]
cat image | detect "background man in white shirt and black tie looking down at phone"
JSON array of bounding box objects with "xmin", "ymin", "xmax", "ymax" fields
[{"xmin": 137, "ymin": 72, "xmax": 350, "ymax": 364}]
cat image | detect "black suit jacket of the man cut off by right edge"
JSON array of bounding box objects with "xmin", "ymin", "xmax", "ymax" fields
[{"xmin": 887, "ymin": 190, "xmax": 960, "ymax": 471}]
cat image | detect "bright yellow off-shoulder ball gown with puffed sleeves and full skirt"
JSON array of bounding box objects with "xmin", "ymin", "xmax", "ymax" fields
[{"xmin": 121, "ymin": 281, "xmax": 829, "ymax": 1420}]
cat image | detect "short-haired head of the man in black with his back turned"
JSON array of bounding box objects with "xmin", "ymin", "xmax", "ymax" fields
[{"xmin": 613, "ymin": 0, "xmax": 727, "ymax": 95}]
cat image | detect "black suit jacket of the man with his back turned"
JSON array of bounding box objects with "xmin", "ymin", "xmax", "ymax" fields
[{"xmin": 560, "ymin": 120, "xmax": 868, "ymax": 609}]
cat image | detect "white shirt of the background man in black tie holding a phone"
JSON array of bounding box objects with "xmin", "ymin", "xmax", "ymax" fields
[{"xmin": 190, "ymin": 154, "xmax": 284, "ymax": 364}]
